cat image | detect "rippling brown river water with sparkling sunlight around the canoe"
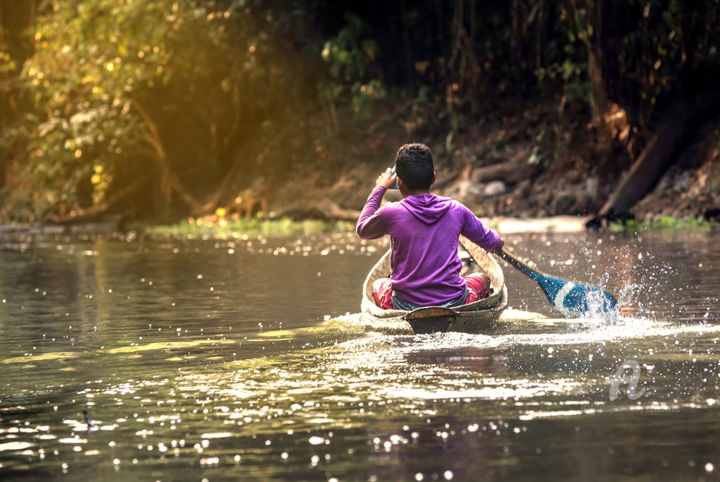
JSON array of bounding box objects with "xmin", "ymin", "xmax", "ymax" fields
[{"xmin": 0, "ymin": 231, "xmax": 720, "ymax": 481}]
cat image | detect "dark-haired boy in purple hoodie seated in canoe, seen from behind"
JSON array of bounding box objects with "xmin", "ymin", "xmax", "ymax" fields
[{"xmin": 356, "ymin": 144, "xmax": 503, "ymax": 311}]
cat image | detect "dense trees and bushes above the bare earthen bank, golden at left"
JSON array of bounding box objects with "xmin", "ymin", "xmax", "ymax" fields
[{"xmin": 0, "ymin": 0, "xmax": 720, "ymax": 222}]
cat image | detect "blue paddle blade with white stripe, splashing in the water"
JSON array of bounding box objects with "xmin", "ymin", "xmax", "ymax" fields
[{"xmin": 536, "ymin": 275, "xmax": 617, "ymax": 315}]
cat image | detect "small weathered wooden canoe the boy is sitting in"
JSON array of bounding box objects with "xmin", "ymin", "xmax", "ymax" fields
[{"xmin": 361, "ymin": 238, "xmax": 508, "ymax": 333}]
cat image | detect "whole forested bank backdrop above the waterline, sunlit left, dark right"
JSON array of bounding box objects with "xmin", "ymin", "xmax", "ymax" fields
[{"xmin": 0, "ymin": 0, "xmax": 720, "ymax": 227}]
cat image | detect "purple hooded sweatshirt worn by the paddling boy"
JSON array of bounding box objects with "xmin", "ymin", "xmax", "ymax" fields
[{"xmin": 356, "ymin": 186, "xmax": 501, "ymax": 306}]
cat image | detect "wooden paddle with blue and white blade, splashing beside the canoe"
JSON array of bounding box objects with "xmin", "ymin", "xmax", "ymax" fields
[{"xmin": 493, "ymin": 248, "xmax": 617, "ymax": 315}]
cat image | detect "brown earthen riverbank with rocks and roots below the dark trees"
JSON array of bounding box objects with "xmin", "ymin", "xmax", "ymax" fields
[{"xmin": 258, "ymin": 98, "xmax": 720, "ymax": 229}]
